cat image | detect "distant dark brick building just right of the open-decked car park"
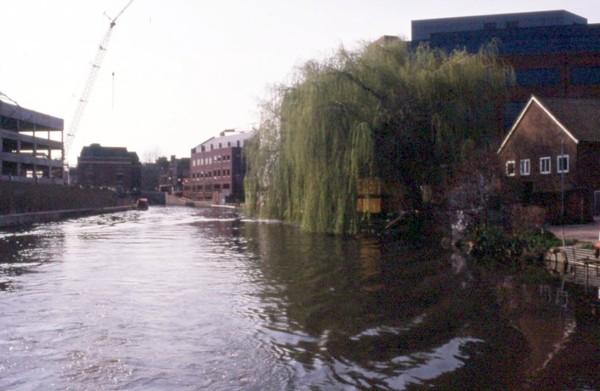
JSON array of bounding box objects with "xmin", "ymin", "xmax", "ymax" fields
[{"xmin": 77, "ymin": 144, "xmax": 141, "ymax": 191}]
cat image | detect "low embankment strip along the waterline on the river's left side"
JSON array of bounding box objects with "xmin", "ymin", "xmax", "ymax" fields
[{"xmin": 0, "ymin": 205, "xmax": 135, "ymax": 229}]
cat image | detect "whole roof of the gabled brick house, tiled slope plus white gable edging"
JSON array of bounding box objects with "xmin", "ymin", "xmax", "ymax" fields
[{"xmin": 498, "ymin": 95, "xmax": 600, "ymax": 153}]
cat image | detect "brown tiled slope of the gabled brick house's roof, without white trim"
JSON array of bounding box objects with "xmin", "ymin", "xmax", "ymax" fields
[{"xmin": 541, "ymin": 98, "xmax": 600, "ymax": 142}]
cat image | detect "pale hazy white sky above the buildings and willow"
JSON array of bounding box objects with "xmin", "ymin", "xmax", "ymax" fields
[{"xmin": 0, "ymin": 0, "xmax": 600, "ymax": 164}]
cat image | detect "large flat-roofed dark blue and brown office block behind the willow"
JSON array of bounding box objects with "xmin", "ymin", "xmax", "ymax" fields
[{"xmin": 412, "ymin": 10, "xmax": 600, "ymax": 127}]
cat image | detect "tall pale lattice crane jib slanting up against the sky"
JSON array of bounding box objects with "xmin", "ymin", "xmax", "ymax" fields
[{"xmin": 64, "ymin": 0, "xmax": 134, "ymax": 156}]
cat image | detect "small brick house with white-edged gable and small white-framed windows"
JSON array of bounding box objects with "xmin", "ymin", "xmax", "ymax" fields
[{"xmin": 498, "ymin": 96, "xmax": 600, "ymax": 222}]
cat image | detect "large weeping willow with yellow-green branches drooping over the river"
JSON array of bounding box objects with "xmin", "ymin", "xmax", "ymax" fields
[{"xmin": 245, "ymin": 40, "xmax": 513, "ymax": 233}]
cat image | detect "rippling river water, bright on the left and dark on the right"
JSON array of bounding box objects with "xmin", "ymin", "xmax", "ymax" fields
[{"xmin": 0, "ymin": 207, "xmax": 600, "ymax": 390}]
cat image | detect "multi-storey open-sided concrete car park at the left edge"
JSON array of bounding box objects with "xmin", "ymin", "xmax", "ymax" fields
[{"xmin": 0, "ymin": 101, "xmax": 64, "ymax": 184}]
